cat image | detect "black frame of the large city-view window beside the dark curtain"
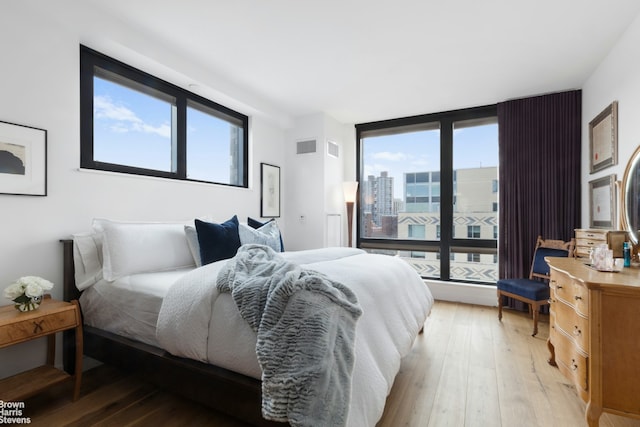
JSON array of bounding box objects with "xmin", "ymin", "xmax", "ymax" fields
[{"xmin": 355, "ymin": 104, "xmax": 498, "ymax": 285}]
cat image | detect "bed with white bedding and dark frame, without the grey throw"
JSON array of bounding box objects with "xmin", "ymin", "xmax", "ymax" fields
[{"xmin": 63, "ymin": 219, "xmax": 433, "ymax": 426}]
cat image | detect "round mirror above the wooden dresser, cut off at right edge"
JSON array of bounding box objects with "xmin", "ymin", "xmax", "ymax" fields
[{"xmin": 620, "ymin": 147, "xmax": 640, "ymax": 245}]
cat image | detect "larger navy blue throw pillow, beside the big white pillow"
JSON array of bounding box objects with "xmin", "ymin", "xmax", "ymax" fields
[{"xmin": 195, "ymin": 215, "xmax": 240, "ymax": 265}]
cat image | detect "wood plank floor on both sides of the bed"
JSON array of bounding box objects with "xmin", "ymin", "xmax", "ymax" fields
[{"xmin": 24, "ymin": 302, "xmax": 640, "ymax": 427}]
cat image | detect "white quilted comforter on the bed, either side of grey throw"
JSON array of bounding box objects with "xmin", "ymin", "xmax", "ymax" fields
[{"xmin": 157, "ymin": 248, "xmax": 433, "ymax": 426}]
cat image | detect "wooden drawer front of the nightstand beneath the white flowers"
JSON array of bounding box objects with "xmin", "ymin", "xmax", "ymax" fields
[{"xmin": 0, "ymin": 306, "xmax": 76, "ymax": 347}]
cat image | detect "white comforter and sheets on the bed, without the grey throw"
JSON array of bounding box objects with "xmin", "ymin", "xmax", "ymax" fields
[{"xmin": 80, "ymin": 248, "xmax": 433, "ymax": 426}]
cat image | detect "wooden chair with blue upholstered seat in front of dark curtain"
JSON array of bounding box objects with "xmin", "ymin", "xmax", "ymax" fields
[{"xmin": 497, "ymin": 236, "xmax": 575, "ymax": 336}]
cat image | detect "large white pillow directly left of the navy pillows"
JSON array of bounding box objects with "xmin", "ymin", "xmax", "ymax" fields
[{"xmin": 94, "ymin": 219, "xmax": 194, "ymax": 281}]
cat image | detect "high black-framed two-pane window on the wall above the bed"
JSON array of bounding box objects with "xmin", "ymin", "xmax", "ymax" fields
[{"xmin": 80, "ymin": 46, "xmax": 249, "ymax": 187}]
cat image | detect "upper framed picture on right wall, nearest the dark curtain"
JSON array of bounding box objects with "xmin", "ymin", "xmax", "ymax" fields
[{"xmin": 589, "ymin": 101, "xmax": 618, "ymax": 173}]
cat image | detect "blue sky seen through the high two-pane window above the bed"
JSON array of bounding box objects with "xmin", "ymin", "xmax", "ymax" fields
[{"xmin": 94, "ymin": 77, "xmax": 231, "ymax": 183}]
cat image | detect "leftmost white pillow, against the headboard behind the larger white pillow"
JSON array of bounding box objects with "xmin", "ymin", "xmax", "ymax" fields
[{"xmin": 72, "ymin": 232, "xmax": 102, "ymax": 291}]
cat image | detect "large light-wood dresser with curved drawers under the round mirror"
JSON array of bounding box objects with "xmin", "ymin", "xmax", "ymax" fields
[{"xmin": 546, "ymin": 257, "xmax": 640, "ymax": 426}]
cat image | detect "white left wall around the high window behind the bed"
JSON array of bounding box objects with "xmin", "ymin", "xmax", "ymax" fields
[{"xmin": 0, "ymin": 1, "xmax": 289, "ymax": 378}]
